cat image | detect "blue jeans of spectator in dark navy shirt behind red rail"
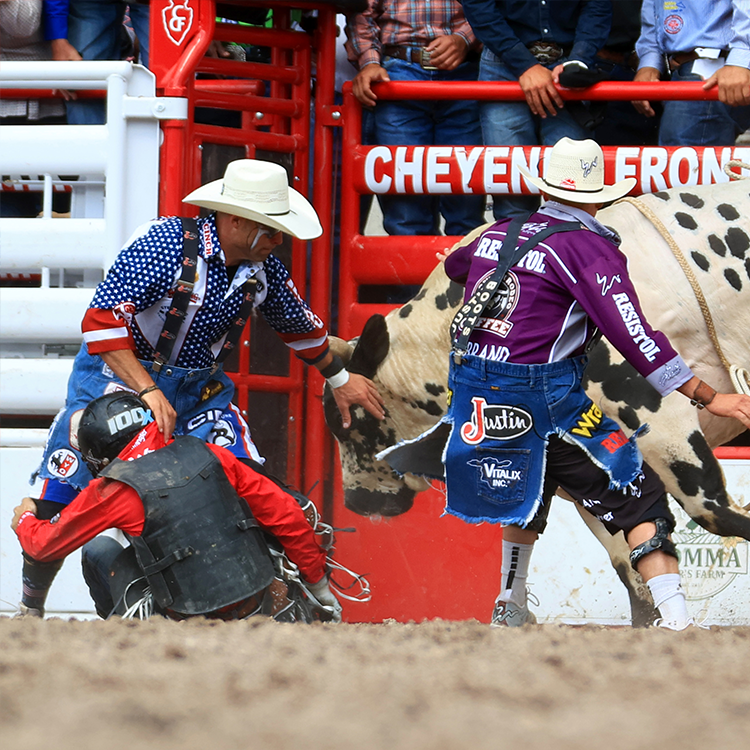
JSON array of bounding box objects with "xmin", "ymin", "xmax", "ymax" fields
[{"xmin": 479, "ymin": 47, "xmax": 591, "ymax": 220}]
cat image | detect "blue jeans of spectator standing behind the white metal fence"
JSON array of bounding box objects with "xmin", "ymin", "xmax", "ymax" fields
[{"xmin": 66, "ymin": 0, "xmax": 149, "ymax": 125}]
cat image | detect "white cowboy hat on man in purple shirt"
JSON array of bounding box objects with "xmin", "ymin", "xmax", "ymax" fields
[{"xmin": 518, "ymin": 138, "xmax": 637, "ymax": 203}]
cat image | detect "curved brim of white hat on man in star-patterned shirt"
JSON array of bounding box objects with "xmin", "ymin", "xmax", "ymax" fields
[{"xmin": 182, "ymin": 179, "xmax": 323, "ymax": 240}]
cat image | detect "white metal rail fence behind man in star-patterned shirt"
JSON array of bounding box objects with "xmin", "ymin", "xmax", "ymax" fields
[{"xmin": 0, "ymin": 62, "xmax": 187, "ymax": 426}]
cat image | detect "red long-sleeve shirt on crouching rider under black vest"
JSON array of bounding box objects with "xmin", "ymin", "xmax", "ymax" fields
[{"xmin": 16, "ymin": 422, "xmax": 326, "ymax": 583}]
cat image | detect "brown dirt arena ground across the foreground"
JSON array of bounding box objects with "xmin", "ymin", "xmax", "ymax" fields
[{"xmin": 0, "ymin": 618, "xmax": 750, "ymax": 750}]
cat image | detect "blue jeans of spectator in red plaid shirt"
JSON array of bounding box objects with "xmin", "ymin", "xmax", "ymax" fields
[{"xmin": 374, "ymin": 57, "xmax": 485, "ymax": 235}]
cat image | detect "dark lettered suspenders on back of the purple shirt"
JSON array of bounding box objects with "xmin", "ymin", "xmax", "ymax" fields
[{"xmin": 451, "ymin": 213, "xmax": 581, "ymax": 364}]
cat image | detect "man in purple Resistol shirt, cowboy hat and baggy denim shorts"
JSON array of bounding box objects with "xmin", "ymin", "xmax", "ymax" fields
[{"xmin": 434, "ymin": 138, "xmax": 750, "ymax": 630}]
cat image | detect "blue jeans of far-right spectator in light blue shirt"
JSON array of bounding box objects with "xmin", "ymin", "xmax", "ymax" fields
[{"xmin": 659, "ymin": 62, "xmax": 750, "ymax": 146}]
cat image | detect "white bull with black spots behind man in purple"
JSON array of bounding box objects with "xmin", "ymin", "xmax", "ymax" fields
[{"xmin": 326, "ymin": 180, "xmax": 750, "ymax": 624}]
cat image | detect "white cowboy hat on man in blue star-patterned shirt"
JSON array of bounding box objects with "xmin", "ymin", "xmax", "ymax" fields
[{"xmin": 183, "ymin": 159, "xmax": 323, "ymax": 240}]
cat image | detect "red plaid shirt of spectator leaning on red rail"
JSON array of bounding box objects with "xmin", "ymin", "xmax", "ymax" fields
[{"xmin": 346, "ymin": 0, "xmax": 476, "ymax": 69}]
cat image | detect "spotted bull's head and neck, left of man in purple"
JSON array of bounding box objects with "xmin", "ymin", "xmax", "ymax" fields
[{"xmin": 324, "ymin": 263, "xmax": 462, "ymax": 516}]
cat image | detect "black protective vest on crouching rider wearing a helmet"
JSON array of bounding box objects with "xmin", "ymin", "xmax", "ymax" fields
[{"xmin": 101, "ymin": 437, "xmax": 274, "ymax": 615}]
